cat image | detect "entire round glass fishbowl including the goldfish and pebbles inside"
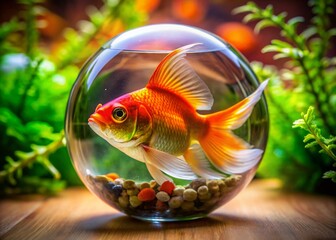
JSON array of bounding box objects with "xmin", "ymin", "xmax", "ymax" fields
[{"xmin": 66, "ymin": 24, "xmax": 268, "ymax": 221}]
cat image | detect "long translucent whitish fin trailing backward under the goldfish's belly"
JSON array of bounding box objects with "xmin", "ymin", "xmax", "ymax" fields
[{"xmin": 143, "ymin": 146, "xmax": 197, "ymax": 180}]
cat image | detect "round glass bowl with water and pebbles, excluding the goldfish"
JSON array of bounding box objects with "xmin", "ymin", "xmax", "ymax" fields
[{"xmin": 66, "ymin": 24, "xmax": 268, "ymax": 221}]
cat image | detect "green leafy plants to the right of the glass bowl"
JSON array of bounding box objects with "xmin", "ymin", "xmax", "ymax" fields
[{"xmin": 234, "ymin": 0, "xmax": 336, "ymax": 191}]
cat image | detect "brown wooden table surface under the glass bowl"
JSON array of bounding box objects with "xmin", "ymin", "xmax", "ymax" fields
[{"xmin": 0, "ymin": 181, "xmax": 336, "ymax": 240}]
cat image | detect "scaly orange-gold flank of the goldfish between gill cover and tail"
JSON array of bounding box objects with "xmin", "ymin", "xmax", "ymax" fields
[{"xmin": 132, "ymin": 88, "xmax": 203, "ymax": 156}]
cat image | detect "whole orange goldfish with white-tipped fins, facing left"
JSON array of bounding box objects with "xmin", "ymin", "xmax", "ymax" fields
[{"xmin": 88, "ymin": 43, "xmax": 267, "ymax": 184}]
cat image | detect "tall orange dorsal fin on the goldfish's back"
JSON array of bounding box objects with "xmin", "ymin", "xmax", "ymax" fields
[{"xmin": 147, "ymin": 43, "xmax": 214, "ymax": 110}]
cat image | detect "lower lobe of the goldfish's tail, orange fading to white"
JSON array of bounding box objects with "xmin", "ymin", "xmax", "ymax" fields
[{"xmin": 200, "ymin": 129, "xmax": 263, "ymax": 174}]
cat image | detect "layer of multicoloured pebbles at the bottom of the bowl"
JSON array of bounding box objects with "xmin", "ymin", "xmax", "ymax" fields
[{"xmin": 87, "ymin": 173, "xmax": 241, "ymax": 215}]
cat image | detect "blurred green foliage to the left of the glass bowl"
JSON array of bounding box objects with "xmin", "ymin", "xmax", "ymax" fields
[{"xmin": 0, "ymin": 0, "xmax": 146, "ymax": 194}]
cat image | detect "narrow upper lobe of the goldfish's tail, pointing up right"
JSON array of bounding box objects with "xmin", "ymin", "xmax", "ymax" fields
[{"xmin": 207, "ymin": 80, "xmax": 268, "ymax": 130}]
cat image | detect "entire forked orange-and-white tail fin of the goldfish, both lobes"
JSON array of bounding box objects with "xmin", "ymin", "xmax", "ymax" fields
[{"xmin": 199, "ymin": 81, "xmax": 267, "ymax": 174}]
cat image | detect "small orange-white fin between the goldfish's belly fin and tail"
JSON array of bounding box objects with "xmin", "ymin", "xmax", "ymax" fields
[{"xmin": 184, "ymin": 144, "xmax": 223, "ymax": 179}]
